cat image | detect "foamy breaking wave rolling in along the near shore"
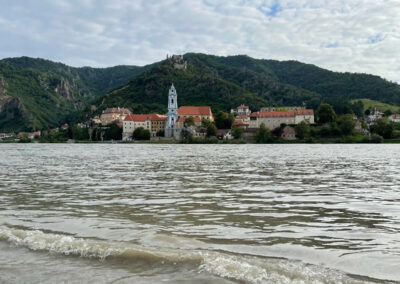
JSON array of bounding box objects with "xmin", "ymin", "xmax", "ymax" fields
[{"xmin": 0, "ymin": 226, "xmax": 376, "ymax": 283}]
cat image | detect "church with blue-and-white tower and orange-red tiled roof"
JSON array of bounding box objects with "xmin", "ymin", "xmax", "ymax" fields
[{"xmin": 165, "ymin": 84, "xmax": 214, "ymax": 140}]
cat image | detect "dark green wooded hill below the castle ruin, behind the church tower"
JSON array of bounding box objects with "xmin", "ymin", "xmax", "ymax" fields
[{"xmin": 98, "ymin": 64, "xmax": 268, "ymax": 113}]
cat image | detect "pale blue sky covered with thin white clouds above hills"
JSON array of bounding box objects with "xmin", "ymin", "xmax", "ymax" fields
[{"xmin": 0, "ymin": 0, "xmax": 400, "ymax": 82}]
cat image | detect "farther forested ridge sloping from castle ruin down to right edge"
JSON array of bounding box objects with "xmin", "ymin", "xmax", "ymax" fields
[{"xmin": 185, "ymin": 53, "xmax": 400, "ymax": 108}]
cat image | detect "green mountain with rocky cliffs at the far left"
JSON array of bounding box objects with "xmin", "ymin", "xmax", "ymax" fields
[{"xmin": 0, "ymin": 57, "xmax": 151, "ymax": 131}]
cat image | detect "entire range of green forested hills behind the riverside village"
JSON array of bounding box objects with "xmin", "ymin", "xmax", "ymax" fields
[{"xmin": 0, "ymin": 53, "xmax": 400, "ymax": 131}]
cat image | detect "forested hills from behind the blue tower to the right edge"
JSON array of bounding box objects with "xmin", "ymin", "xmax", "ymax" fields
[{"xmin": 97, "ymin": 53, "xmax": 400, "ymax": 115}]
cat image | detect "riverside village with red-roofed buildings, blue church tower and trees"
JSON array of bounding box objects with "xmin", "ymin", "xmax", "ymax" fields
[{"xmin": 0, "ymin": 82, "xmax": 400, "ymax": 143}]
